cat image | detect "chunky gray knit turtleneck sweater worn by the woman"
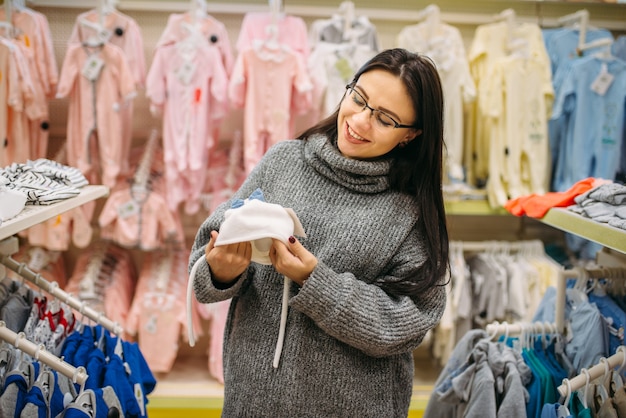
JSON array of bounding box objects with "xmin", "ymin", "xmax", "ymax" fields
[{"xmin": 190, "ymin": 136, "xmax": 445, "ymax": 418}]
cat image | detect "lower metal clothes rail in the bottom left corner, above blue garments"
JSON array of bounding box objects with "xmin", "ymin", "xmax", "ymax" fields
[{"xmin": 0, "ymin": 321, "xmax": 88, "ymax": 392}]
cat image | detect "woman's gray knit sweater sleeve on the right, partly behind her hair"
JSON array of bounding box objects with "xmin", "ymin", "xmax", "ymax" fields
[{"xmin": 290, "ymin": 227, "xmax": 446, "ymax": 357}]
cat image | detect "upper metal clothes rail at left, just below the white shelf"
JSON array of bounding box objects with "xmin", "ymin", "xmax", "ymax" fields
[{"xmin": 0, "ymin": 237, "xmax": 124, "ymax": 335}]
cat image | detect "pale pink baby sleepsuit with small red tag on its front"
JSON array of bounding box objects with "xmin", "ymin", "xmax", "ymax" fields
[{"xmin": 146, "ymin": 34, "xmax": 228, "ymax": 211}]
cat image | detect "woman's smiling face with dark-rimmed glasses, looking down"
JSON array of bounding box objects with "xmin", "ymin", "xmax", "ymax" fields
[{"xmin": 337, "ymin": 70, "xmax": 419, "ymax": 159}]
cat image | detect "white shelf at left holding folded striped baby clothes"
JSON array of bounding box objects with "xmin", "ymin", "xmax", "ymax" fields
[{"xmin": 0, "ymin": 185, "xmax": 109, "ymax": 241}]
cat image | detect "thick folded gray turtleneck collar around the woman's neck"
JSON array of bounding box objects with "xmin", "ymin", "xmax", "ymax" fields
[{"xmin": 304, "ymin": 135, "xmax": 391, "ymax": 193}]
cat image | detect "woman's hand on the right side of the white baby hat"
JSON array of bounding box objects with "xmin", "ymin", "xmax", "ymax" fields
[{"xmin": 270, "ymin": 237, "xmax": 317, "ymax": 286}]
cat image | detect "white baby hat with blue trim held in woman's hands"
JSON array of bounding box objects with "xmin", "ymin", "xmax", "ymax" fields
[{"xmin": 215, "ymin": 189, "xmax": 306, "ymax": 265}]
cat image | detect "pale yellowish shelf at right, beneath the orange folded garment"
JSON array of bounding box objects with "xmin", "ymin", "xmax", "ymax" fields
[{"xmin": 539, "ymin": 208, "xmax": 626, "ymax": 254}]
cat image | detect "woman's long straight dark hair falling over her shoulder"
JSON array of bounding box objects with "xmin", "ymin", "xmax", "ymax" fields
[{"xmin": 298, "ymin": 48, "xmax": 449, "ymax": 295}]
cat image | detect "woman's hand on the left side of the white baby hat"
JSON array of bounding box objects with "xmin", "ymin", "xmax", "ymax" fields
[{"xmin": 205, "ymin": 231, "xmax": 252, "ymax": 283}]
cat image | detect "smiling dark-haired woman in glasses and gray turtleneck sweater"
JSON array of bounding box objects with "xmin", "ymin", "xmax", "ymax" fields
[{"xmin": 190, "ymin": 49, "xmax": 448, "ymax": 417}]
